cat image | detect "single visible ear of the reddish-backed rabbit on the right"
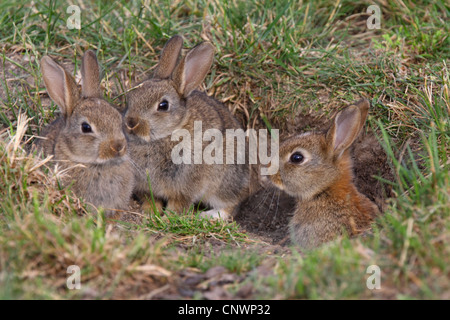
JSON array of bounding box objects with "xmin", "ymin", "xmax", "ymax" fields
[{"xmin": 326, "ymin": 100, "xmax": 369, "ymax": 158}]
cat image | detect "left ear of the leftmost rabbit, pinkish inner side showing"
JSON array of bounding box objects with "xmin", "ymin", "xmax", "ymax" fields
[{"xmin": 41, "ymin": 56, "xmax": 79, "ymax": 118}]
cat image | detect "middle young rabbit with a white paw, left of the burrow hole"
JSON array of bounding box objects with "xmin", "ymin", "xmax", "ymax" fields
[{"xmin": 124, "ymin": 36, "xmax": 250, "ymax": 219}]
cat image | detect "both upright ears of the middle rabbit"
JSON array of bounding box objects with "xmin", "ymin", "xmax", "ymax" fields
[{"xmin": 153, "ymin": 35, "xmax": 214, "ymax": 97}]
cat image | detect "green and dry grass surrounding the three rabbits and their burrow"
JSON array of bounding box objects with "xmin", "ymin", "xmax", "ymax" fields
[{"xmin": 0, "ymin": 0, "xmax": 450, "ymax": 299}]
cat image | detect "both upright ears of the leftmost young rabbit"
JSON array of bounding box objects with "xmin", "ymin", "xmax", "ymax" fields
[{"xmin": 41, "ymin": 50, "xmax": 103, "ymax": 118}]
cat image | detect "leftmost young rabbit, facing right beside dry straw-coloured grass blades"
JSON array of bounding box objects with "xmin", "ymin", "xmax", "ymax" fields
[{"xmin": 37, "ymin": 51, "xmax": 134, "ymax": 215}]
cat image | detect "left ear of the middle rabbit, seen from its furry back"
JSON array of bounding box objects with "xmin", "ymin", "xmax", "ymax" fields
[{"xmin": 153, "ymin": 35, "xmax": 183, "ymax": 79}]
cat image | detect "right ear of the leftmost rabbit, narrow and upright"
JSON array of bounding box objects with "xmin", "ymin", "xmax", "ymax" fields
[{"xmin": 81, "ymin": 50, "xmax": 103, "ymax": 98}]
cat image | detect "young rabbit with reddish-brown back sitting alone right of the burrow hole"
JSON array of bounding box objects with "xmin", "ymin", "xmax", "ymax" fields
[{"xmin": 269, "ymin": 100, "xmax": 378, "ymax": 249}]
